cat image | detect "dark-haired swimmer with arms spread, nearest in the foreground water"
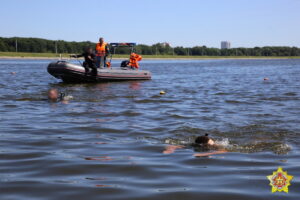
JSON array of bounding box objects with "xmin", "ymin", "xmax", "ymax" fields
[{"xmin": 163, "ymin": 134, "xmax": 227, "ymax": 157}]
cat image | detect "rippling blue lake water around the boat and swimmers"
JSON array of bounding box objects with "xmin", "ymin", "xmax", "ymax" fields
[{"xmin": 0, "ymin": 59, "xmax": 300, "ymax": 200}]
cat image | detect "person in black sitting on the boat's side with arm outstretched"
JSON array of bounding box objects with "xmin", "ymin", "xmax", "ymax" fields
[{"xmin": 70, "ymin": 47, "xmax": 97, "ymax": 76}]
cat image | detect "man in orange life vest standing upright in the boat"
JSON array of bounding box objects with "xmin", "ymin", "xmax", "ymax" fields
[{"xmin": 96, "ymin": 37, "xmax": 109, "ymax": 69}]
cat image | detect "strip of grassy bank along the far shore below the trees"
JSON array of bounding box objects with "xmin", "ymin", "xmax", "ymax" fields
[{"xmin": 0, "ymin": 52, "xmax": 300, "ymax": 59}]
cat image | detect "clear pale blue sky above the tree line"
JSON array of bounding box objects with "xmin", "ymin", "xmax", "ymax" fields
[{"xmin": 0, "ymin": 0, "xmax": 300, "ymax": 47}]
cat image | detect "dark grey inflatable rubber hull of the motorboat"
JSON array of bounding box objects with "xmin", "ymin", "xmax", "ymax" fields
[{"xmin": 47, "ymin": 61, "xmax": 151, "ymax": 83}]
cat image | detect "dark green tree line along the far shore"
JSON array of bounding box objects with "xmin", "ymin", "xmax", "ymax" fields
[{"xmin": 0, "ymin": 37, "xmax": 300, "ymax": 56}]
